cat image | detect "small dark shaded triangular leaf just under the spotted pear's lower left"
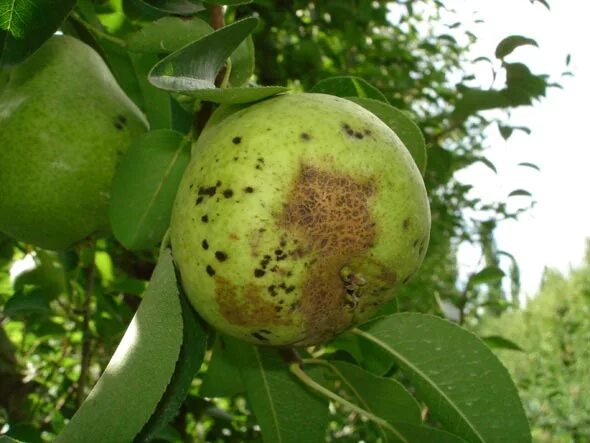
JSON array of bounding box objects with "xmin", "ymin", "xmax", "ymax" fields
[{"xmin": 199, "ymin": 334, "xmax": 244, "ymax": 398}]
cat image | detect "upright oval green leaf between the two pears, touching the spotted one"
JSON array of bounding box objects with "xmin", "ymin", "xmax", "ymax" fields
[{"xmin": 109, "ymin": 129, "xmax": 190, "ymax": 249}]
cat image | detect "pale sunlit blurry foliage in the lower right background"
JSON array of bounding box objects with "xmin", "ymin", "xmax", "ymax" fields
[{"xmin": 481, "ymin": 244, "xmax": 590, "ymax": 443}]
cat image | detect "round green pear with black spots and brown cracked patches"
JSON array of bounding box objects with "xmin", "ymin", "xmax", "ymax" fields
[{"xmin": 170, "ymin": 94, "xmax": 430, "ymax": 346}]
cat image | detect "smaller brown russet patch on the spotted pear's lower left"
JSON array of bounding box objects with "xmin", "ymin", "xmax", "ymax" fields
[{"xmin": 215, "ymin": 276, "xmax": 293, "ymax": 327}]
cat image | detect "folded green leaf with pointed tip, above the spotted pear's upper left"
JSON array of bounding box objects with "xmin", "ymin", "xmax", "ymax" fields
[{"xmin": 149, "ymin": 17, "xmax": 258, "ymax": 92}]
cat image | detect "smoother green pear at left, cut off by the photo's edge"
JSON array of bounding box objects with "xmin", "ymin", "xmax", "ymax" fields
[{"xmin": 0, "ymin": 36, "xmax": 147, "ymax": 249}]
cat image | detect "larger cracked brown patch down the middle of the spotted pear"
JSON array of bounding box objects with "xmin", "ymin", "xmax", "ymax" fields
[{"xmin": 280, "ymin": 165, "xmax": 375, "ymax": 345}]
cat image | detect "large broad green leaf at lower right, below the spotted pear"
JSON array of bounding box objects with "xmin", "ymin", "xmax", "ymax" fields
[{"xmin": 358, "ymin": 313, "xmax": 531, "ymax": 443}]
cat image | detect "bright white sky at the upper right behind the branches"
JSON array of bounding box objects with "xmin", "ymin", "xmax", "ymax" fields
[{"xmin": 445, "ymin": 0, "xmax": 590, "ymax": 299}]
